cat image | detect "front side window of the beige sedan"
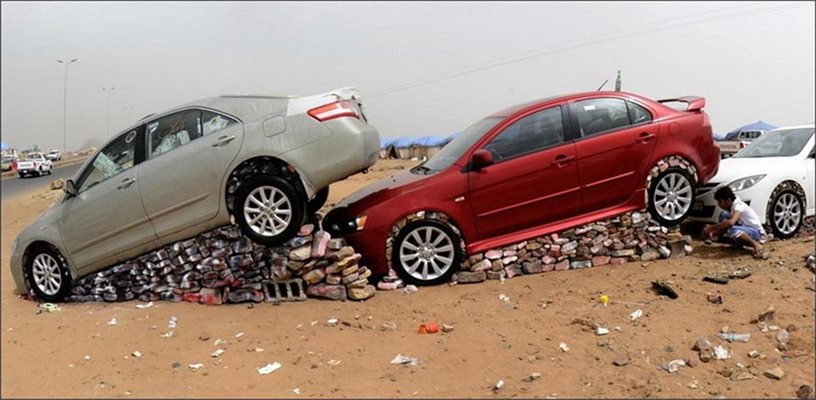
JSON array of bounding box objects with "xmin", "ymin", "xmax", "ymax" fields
[{"xmin": 79, "ymin": 130, "xmax": 139, "ymax": 192}]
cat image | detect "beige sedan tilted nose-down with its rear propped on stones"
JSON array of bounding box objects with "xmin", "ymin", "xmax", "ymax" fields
[{"xmin": 11, "ymin": 88, "xmax": 380, "ymax": 301}]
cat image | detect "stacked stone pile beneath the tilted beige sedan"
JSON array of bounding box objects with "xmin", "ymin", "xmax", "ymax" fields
[{"xmin": 67, "ymin": 225, "xmax": 375, "ymax": 304}]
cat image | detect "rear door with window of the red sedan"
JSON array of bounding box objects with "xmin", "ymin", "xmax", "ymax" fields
[{"xmin": 571, "ymin": 98, "xmax": 658, "ymax": 211}]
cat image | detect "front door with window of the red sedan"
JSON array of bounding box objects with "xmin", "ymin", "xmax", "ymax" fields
[{"xmin": 468, "ymin": 106, "xmax": 581, "ymax": 238}]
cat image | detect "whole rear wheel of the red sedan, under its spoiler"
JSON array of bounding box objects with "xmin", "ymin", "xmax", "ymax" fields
[{"xmin": 649, "ymin": 167, "xmax": 695, "ymax": 226}]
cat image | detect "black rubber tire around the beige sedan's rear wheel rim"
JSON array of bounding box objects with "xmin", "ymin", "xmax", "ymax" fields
[{"xmin": 233, "ymin": 175, "xmax": 306, "ymax": 246}]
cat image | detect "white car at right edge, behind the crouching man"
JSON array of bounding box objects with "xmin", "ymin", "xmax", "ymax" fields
[{"xmin": 689, "ymin": 125, "xmax": 816, "ymax": 239}]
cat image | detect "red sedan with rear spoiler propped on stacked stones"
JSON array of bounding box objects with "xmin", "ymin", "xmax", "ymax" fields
[{"xmin": 324, "ymin": 92, "xmax": 720, "ymax": 285}]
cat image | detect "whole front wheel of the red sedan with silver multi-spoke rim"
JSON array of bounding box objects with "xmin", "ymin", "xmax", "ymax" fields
[{"xmin": 391, "ymin": 220, "xmax": 462, "ymax": 286}]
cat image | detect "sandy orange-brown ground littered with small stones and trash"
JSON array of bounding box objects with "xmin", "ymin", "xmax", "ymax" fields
[{"xmin": 0, "ymin": 161, "xmax": 815, "ymax": 398}]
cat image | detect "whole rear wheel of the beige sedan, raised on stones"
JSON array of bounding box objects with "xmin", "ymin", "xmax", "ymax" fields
[{"xmin": 235, "ymin": 175, "xmax": 306, "ymax": 246}]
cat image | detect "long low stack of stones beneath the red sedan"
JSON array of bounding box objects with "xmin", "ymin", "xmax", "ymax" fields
[{"xmin": 455, "ymin": 211, "xmax": 693, "ymax": 283}]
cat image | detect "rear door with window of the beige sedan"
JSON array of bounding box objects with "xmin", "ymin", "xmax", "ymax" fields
[{"xmin": 139, "ymin": 109, "xmax": 243, "ymax": 238}]
